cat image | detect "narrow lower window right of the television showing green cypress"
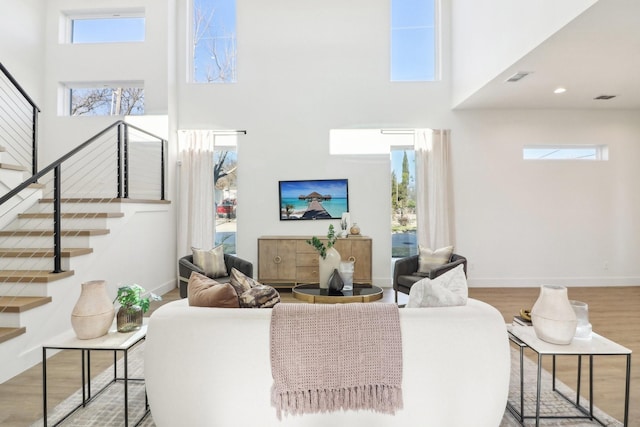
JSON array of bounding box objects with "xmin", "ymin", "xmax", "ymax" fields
[{"xmin": 391, "ymin": 147, "xmax": 418, "ymax": 257}]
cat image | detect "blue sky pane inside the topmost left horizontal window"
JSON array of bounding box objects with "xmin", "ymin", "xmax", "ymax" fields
[{"xmin": 71, "ymin": 17, "xmax": 145, "ymax": 44}]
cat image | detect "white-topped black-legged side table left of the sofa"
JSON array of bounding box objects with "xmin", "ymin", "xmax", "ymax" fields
[{"xmin": 42, "ymin": 319, "xmax": 149, "ymax": 427}]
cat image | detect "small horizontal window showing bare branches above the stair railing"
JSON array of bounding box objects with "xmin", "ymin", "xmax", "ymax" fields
[{"xmin": 64, "ymin": 82, "xmax": 144, "ymax": 116}]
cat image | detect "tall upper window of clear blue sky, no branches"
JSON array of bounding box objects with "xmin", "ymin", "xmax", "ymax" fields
[{"xmin": 391, "ymin": 0, "xmax": 436, "ymax": 81}]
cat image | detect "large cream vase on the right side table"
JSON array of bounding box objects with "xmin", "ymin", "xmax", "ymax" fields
[{"xmin": 531, "ymin": 285, "xmax": 578, "ymax": 345}]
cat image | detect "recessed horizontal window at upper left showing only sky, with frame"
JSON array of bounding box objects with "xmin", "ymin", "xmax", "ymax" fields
[{"xmin": 64, "ymin": 11, "xmax": 145, "ymax": 44}]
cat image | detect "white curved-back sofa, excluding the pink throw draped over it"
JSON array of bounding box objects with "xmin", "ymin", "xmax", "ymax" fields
[{"xmin": 144, "ymin": 299, "xmax": 510, "ymax": 427}]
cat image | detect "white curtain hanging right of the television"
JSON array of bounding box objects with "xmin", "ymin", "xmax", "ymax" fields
[{"xmin": 414, "ymin": 129, "xmax": 455, "ymax": 250}]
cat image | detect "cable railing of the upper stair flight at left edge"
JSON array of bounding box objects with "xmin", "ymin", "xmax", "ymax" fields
[{"xmin": 0, "ymin": 63, "xmax": 40, "ymax": 175}]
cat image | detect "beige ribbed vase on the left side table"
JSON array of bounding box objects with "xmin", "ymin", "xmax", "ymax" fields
[{"xmin": 71, "ymin": 280, "xmax": 115, "ymax": 340}]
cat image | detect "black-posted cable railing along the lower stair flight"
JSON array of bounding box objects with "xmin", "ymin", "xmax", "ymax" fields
[{"xmin": 0, "ymin": 121, "xmax": 167, "ymax": 312}]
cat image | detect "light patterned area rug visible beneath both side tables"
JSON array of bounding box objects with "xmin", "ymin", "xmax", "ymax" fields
[{"xmin": 32, "ymin": 343, "xmax": 622, "ymax": 427}]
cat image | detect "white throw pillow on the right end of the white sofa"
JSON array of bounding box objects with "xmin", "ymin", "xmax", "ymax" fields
[{"xmin": 407, "ymin": 264, "xmax": 469, "ymax": 307}]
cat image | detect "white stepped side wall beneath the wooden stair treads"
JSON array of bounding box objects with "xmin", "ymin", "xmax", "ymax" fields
[{"xmin": 0, "ymin": 202, "xmax": 177, "ymax": 383}]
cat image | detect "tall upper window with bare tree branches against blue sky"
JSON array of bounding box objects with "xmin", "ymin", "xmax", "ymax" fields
[{"xmin": 191, "ymin": 0, "xmax": 237, "ymax": 83}]
